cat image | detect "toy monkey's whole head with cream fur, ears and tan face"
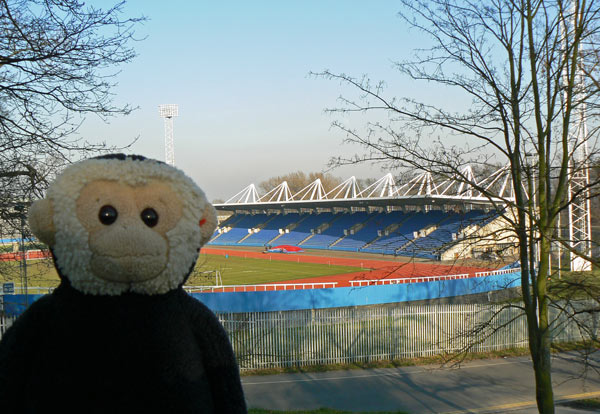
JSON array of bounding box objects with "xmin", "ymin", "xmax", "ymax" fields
[{"xmin": 29, "ymin": 154, "xmax": 217, "ymax": 295}]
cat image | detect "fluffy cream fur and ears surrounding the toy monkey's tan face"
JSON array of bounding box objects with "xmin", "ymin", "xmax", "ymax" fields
[{"xmin": 30, "ymin": 159, "xmax": 217, "ymax": 295}]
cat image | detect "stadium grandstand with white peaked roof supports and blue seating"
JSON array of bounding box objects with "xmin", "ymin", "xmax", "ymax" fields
[{"xmin": 208, "ymin": 166, "xmax": 515, "ymax": 260}]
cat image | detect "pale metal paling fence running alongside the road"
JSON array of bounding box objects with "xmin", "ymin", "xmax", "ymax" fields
[{"xmin": 0, "ymin": 301, "xmax": 600, "ymax": 370}]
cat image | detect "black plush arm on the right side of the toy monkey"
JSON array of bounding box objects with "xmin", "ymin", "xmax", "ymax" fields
[{"xmin": 189, "ymin": 297, "xmax": 247, "ymax": 414}]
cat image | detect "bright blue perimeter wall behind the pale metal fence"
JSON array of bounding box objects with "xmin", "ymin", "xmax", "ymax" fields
[{"xmin": 3, "ymin": 272, "xmax": 521, "ymax": 315}]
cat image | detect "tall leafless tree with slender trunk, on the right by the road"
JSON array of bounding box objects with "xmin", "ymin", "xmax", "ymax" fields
[{"xmin": 315, "ymin": 0, "xmax": 600, "ymax": 413}]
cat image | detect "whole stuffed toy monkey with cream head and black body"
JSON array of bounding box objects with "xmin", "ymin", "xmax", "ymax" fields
[{"xmin": 0, "ymin": 154, "xmax": 246, "ymax": 414}]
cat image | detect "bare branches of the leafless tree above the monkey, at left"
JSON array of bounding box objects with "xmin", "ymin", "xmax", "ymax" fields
[{"xmin": 0, "ymin": 0, "xmax": 143, "ymax": 233}]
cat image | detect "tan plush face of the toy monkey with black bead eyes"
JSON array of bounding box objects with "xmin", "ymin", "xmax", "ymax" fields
[{"xmin": 76, "ymin": 180, "xmax": 182, "ymax": 283}]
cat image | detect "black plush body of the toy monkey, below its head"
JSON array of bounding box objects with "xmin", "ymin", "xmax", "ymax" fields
[{"xmin": 0, "ymin": 281, "xmax": 246, "ymax": 414}]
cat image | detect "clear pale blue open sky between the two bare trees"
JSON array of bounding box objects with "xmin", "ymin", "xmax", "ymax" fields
[{"xmin": 80, "ymin": 0, "xmax": 418, "ymax": 200}]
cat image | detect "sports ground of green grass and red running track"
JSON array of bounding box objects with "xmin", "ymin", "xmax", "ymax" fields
[{"xmin": 0, "ymin": 248, "xmax": 489, "ymax": 288}]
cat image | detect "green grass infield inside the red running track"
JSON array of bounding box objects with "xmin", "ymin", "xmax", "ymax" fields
[{"xmin": 0, "ymin": 254, "xmax": 361, "ymax": 287}]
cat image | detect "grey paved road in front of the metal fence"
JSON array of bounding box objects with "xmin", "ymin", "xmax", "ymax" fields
[{"xmin": 243, "ymin": 352, "xmax": 600, "ymax": 414}]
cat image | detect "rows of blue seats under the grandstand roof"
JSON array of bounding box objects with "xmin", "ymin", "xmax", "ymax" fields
[{"xmin": 209, "ymin": 210, "xmax": 497, "ymax": 258}]
